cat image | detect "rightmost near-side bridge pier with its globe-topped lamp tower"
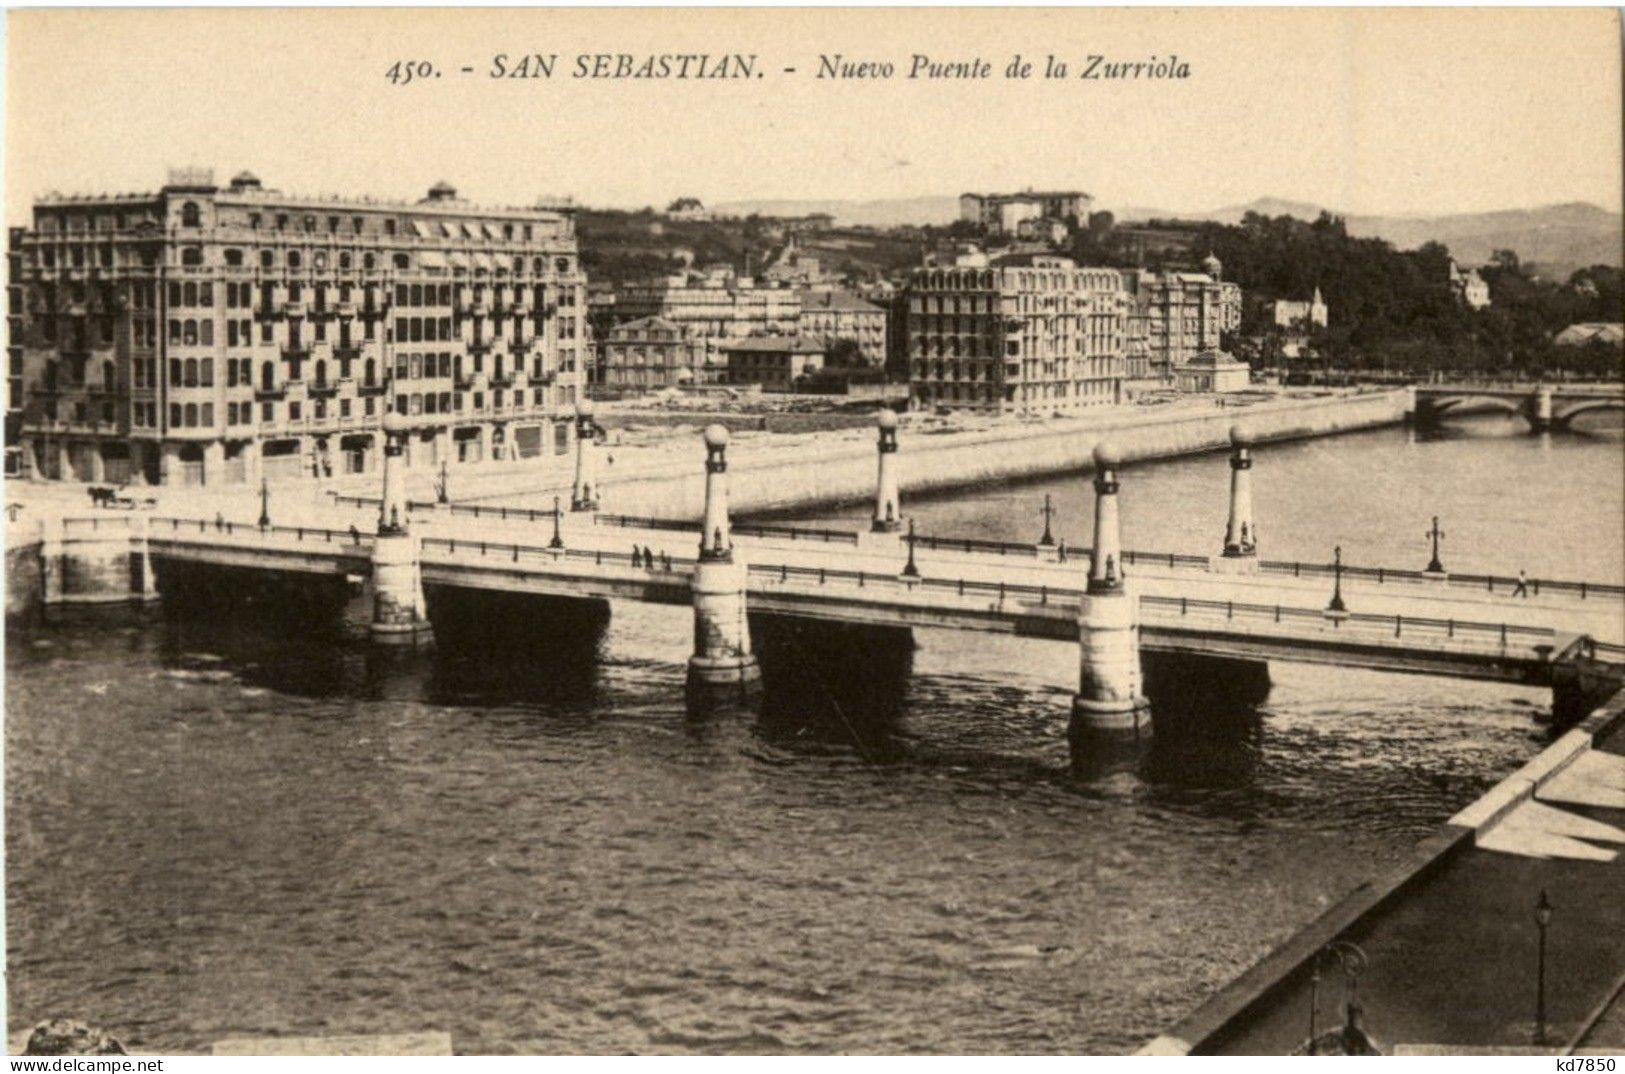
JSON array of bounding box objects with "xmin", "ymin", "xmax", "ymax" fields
[{"xmin": 1073, "ymin": 444, "xmax": 1151, "ymax": 736}]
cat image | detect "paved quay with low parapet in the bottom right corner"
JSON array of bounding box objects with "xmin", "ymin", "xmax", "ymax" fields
[{"xmin": 1144, "ymin": 694, "xmax": 1625, "ymax": 1055}]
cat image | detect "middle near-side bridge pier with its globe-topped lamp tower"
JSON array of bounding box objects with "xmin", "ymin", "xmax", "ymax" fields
[{"xmin": 689, "ymin": 426, "xmax": 762, "ymax": 708}]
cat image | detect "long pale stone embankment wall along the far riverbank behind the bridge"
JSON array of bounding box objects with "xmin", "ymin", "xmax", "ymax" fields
[{"xmin": 594, "ymin": 390, "xmax": 1412, "ymax": 518}]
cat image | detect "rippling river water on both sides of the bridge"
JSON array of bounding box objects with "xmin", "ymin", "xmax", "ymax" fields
[{"xmin": 5, "ymin": 419, "xmax": 1625, "ymax": 1053}]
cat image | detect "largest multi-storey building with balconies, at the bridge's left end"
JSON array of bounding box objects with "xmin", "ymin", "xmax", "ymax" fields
[{"xmin": 8, "ymin": 169, "xmax": 588, "ymax": 486}]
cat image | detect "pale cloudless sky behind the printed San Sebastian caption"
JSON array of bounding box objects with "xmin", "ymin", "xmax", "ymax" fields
[{"xmin": 5, "ymin": 8, "xmax": 1622, "ymax": 224}]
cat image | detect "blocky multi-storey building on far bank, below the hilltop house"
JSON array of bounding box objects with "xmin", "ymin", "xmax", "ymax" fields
[{"xmin": 905, "ymin": 257, "xmax": 1129, "ymax": 414}]
